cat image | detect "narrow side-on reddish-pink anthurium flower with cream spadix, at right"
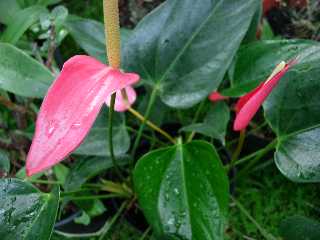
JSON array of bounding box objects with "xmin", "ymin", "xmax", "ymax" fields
[{"xmin": 233, "ymin": 60, "xmax": 296, "ymax": 131}]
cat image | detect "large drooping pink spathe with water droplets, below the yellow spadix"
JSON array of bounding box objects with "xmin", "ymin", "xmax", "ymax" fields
[{"xmin": 26, "ymin": 56, "xmax": 139, "ymax": 176}]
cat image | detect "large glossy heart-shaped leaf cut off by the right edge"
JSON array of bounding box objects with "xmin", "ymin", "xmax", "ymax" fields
[{"xmin": 264, "ymin": 45, "xmax": 320, "ymax": 182}]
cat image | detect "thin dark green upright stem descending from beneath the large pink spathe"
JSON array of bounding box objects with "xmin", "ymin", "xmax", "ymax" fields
[{"xmin": 108, "ymin": 93, "xmax": 124, "ymax": 180}]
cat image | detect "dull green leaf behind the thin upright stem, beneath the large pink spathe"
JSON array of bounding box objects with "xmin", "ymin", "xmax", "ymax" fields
[{"xmin": 74, "ymin": 110, "xmax": 130, "ymax": 157}]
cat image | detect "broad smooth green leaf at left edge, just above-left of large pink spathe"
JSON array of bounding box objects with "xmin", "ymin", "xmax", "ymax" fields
[{"xmin": 0, "ymin": 43, "xmax": 53, "ymax": 98}]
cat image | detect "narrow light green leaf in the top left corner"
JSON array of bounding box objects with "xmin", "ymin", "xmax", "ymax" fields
[{"xmin": 1, "ymin": 6, "xmax": 47, "ymax": 44}]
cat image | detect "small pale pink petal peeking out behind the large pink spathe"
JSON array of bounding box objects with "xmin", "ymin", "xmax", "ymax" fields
[{"xmin": 106, "ymin": 86, "xmax": 137, "ymax": 112}]
